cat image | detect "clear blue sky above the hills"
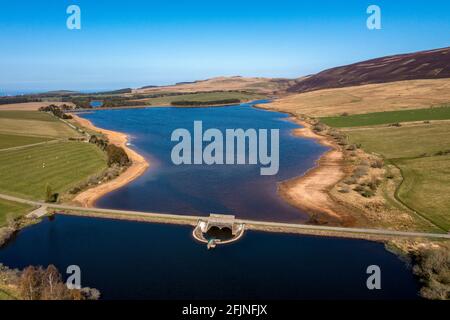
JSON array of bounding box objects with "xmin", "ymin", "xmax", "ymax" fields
[{"xmin": 0, "ymin": 0, "xmax": 450, "ymax": 92}]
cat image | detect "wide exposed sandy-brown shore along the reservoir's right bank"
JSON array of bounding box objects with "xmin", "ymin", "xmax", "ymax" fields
[{"xmin": 279, "ymin": 118, "xmax": 355, "ymax": 226}]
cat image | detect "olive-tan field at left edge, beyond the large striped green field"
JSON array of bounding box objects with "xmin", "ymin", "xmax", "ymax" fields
[{"xmin": 0, "ymin": 111, "xmax": 79, "ymax": 138}]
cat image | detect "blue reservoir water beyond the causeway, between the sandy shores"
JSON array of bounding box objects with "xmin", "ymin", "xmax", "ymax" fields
[{"xmin": 81, "ymin": 104, "xmax": 326, "ymax": 222}]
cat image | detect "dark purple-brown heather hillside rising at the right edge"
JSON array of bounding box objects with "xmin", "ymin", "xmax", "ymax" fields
[{"xmin": 287, "ymin": 47, "xmax": 450, "ymax": 93}]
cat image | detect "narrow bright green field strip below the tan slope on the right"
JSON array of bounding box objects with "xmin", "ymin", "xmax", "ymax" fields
[{"xmin": 320, "ymin": 106, "xmax": 450, "ymax": 128}]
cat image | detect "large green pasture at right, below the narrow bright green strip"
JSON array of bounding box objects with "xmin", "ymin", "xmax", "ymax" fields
[{"xmin": 343, "ymin": 123, "xmax": 450, "ymax": 230}]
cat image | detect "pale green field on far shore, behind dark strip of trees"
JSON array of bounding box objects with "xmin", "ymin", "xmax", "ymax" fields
[{"xmin": 130, "ymin": 92, "xmax": 266, "ymax": 106}]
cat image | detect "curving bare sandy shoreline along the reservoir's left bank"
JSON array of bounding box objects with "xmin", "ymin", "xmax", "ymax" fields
[{"xmin": 72, "ymin": 114, "xmax": 149, "ymax": 207}]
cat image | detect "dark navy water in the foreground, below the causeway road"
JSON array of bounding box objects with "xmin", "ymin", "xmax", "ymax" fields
[{"xmin": 0, "ymin": 216, "xmax": 418, "ymax": 299}]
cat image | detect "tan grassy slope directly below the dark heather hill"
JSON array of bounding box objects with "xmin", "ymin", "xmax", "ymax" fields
[{"xmin": 267, "ymin": 79, "xmax": 450, "ymax": 117}]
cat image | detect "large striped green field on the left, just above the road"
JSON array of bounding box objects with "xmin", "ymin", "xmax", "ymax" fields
[{"xmin": 0, "ymin": 142, "xmax": 106, "ymax": 200}]
